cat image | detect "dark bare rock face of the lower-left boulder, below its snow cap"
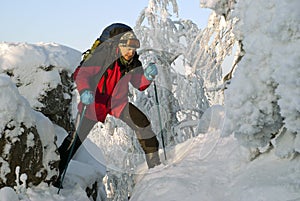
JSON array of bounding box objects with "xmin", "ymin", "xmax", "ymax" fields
[{"xmin": 0, "ymin": 120, "xmax": 58, "ymax": 187}]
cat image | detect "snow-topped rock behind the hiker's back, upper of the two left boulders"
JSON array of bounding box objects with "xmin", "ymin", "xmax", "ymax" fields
[{"xmin": 0, "ymin": 43, "xmax": 81, "ymax": 131}]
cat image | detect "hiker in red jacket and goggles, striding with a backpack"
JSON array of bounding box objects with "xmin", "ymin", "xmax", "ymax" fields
[{"xmin": 54, "ymin": 23, "xmax": 160, "ymax": 187}]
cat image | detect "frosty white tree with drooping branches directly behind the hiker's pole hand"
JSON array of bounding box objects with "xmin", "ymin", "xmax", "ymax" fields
[{"xmin": 135, "ymin": 0, "xmax": 209, "ymax": 145}]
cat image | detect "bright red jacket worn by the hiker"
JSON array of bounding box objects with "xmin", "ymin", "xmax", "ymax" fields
[{"xmin": 74, "ymin": 56, "xmax": 151, "ymax": 122}]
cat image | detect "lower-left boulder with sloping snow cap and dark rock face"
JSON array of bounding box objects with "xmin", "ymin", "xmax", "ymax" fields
[{"xmin": 0, "ymin": 74, "xmax": 59, "ymax": 187}]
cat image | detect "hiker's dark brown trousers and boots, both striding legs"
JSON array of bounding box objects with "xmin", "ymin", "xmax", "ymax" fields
[{"xmin": 58, "ymin": 103, "xmax": 160, "ymax": 177}]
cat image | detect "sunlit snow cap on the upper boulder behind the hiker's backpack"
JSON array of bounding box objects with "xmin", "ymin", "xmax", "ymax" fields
[{"xmin": 0, "ymin": 42, "xmax": 81, "ymax": 108}]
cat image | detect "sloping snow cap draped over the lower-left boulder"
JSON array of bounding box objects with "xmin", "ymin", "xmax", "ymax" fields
[{"xmin": 0, "ymin": 74, "xmax": 57, "ymax": 184}]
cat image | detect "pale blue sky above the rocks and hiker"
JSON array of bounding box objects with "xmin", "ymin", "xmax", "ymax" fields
[{"xmin": 0, "ymin": 0, "xmax": 211, "ymax": 51}]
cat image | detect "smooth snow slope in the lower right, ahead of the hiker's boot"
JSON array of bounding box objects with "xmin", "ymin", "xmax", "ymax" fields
[{"xmin": 130, "ymin": 131, "xmax": 300, "ymax": 201}]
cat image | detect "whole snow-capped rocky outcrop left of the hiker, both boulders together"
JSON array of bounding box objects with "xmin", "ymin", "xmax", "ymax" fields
[{"xmin": 0, "ymin": 43, "xmax": 81, "ymax": 187}]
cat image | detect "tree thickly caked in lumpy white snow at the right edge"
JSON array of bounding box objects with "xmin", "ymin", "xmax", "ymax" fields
[{"xmin": 223, "ymin": 0, "xmax": 300, "ymax": 157}]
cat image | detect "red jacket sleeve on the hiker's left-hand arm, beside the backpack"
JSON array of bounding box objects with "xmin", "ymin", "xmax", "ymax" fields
[{"xmin": 73, "ymin": 66, "xmax": 101, "ymax": 94}]
